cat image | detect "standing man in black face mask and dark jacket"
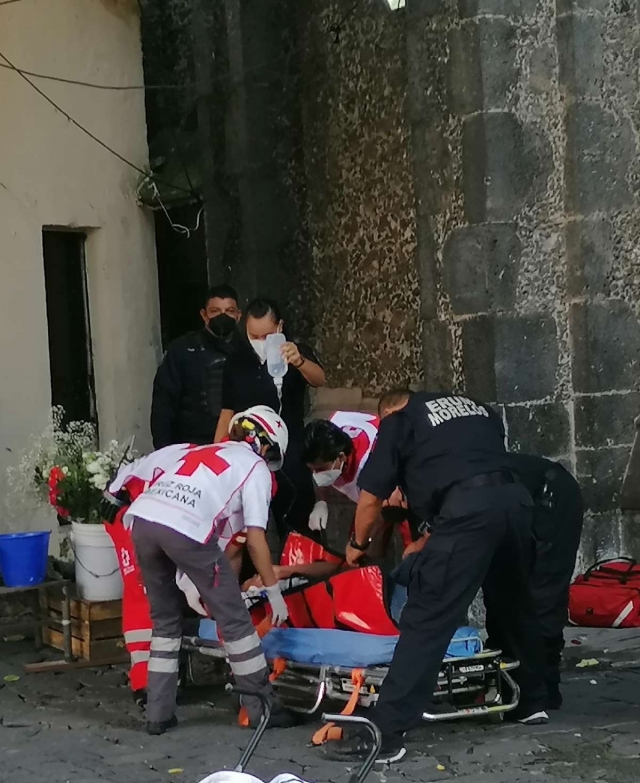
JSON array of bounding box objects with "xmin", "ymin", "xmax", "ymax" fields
[{"xmin": 151, "ymin": 285, "xmax": 242, "ymax": 449}]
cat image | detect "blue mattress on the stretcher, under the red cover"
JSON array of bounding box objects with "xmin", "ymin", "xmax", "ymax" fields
[{"xmin": 200, "ymin": 620, "xmax": 482, "ymax": 668}]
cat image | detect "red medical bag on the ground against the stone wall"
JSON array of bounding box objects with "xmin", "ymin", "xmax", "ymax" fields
[{"xmin": 569, "ymin": 557, "xmax": 640, "ymax": 628}]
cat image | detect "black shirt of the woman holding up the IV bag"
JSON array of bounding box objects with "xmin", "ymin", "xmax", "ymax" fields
[{"xmin": 222, "ymin": 341, "xmax": 320, "ymax": 443}]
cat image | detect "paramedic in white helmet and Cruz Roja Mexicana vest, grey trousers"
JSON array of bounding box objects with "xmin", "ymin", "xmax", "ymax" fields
[{"xmin": 124, "ymin": 409, "xmax": 292, "ymax": 734}]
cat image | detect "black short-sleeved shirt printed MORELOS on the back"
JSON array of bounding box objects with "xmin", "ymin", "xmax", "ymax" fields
[{"xmin": 358, "ymin": 392, "xmax": 510, "ymax": 519}]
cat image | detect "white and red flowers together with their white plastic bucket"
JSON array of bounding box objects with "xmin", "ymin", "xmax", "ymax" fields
[{"xmin": 9, "ymin": 407, "xmax": 134, "ymax": 601}]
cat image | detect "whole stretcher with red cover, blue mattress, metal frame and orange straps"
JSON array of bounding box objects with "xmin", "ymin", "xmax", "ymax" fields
[{"xmin": 184, "ymin": 534, "xmax": 520, "ymax": 728}]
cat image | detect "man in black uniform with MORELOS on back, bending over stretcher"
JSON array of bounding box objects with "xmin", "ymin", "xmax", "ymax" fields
[{"xmin": 331, "ymin": 392, "xmax": 548, "ymax": 763}]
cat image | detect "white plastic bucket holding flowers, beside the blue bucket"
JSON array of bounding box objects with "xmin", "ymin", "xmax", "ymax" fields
[{"xmin": 71, "ymin": 522, "xmax": 122, "ymax": 601}]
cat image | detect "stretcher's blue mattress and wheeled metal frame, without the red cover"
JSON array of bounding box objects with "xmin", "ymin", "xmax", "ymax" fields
[{"xmin": 184, "ymin": 588, "xmax": 520, "ymax": 721}]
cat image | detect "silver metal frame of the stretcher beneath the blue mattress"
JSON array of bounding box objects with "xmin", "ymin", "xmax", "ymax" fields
[{"xmin": 183, "ymin": 636, "xmax": 520, "ymax": 722}]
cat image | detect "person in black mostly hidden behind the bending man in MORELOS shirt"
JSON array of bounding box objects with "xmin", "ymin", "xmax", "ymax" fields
[{"xmin": 500, "ymin": 454, "xmax": 584, "ymax": 710}]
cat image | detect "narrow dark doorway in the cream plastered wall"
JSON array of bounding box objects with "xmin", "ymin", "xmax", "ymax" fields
[{"xmin": 42, "ymin": 228, "xmax": 97, "ymax": 426}]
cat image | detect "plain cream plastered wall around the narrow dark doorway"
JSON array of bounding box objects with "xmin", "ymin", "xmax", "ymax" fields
[{"xmin": 0, "ymin": 0, "xmax": 159, "ymax": 531}]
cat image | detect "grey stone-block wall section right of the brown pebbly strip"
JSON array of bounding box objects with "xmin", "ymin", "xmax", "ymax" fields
[{"xmin": 407, "ymin": 0, "xmax": 640, "ymax": 560}]
